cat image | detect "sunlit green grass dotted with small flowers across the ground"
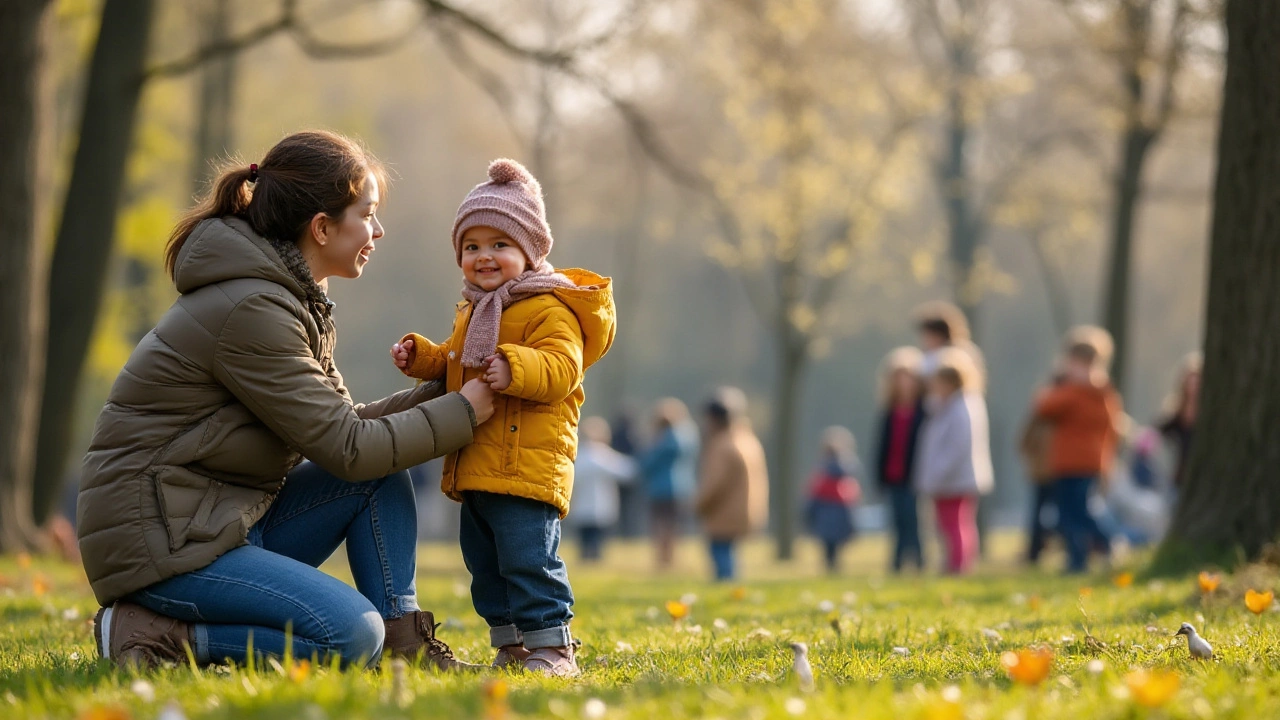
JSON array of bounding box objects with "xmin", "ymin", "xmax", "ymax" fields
[{"xmin": 0, "ymin": 538, "xmax": 1280, "ymax": 720}]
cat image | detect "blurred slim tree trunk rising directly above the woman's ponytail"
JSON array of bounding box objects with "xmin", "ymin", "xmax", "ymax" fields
[{"xmin": 191, "ymin": 0, "xmax": 236, "ymax": 193}]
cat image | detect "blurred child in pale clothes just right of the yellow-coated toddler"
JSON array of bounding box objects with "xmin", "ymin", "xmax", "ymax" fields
[{"xmin": 566, "ymin": 418, "xmax": 636, "ymax": 562}]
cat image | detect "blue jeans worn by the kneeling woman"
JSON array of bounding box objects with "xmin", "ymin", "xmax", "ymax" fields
[{"xmin": 127, "ymin": 462, "xmax": 419, "ymax": 666}]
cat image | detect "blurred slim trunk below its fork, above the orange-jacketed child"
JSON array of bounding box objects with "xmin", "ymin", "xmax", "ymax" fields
[{"xmin": 1102, "ymin": 119, "xmax": 1156, "ymax": 391}]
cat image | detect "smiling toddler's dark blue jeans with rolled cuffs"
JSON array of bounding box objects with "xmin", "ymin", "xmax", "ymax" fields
[{"xmin": 458, "ymin": 492, "xmax": 573, "ymax": 650}]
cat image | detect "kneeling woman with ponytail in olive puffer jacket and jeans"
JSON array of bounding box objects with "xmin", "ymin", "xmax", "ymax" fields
[{"xmin": 78, "ymin": 132, "xmax": 493, "ymax": 670}]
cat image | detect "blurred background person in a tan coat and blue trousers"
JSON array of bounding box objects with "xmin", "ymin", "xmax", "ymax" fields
[{"xmin": 695, "ymin": 388, "xmax": 769, "ymax": 580}]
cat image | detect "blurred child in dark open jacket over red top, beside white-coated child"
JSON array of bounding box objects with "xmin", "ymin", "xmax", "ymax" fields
[{"xmin": 876, "ymin": 347, "xmax": 924, "ymax": 573}]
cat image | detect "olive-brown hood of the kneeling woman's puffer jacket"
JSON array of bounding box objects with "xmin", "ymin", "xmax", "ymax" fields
[{"xmin": 173, "ymin": 217, "xmax": 306, "ymax": 300}]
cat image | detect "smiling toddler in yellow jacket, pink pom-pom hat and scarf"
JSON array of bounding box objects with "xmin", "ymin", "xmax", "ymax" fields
[{"xmin": 388, "ymin": 160, "xmax": 616, "ymax": 676}]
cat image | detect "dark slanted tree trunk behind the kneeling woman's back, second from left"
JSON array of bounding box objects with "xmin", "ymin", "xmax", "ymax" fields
[{"xmin": 35, "ymin": 0, "xmax": 154, "ymax": 521}]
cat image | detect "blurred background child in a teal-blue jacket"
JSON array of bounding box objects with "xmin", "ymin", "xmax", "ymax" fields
[{"xmin": 637, "ymin": 397, "xmax": 699, "ymax": 570}]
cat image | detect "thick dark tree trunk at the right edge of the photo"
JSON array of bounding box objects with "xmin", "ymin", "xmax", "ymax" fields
[{"xmin": 1158, "ymin": 0, "xmax": 1280, "ymax": 566}]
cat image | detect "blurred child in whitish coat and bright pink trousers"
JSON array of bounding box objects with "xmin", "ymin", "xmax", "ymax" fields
[{"xmin": 915, "ymin": 347, "xmax": 995, "ymax": 574}]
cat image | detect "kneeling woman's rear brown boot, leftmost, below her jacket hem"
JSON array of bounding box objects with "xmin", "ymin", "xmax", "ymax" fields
[{"xmin": 93, "ymin": 602, "xmax": 196, "ymax": 670}]
